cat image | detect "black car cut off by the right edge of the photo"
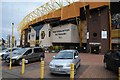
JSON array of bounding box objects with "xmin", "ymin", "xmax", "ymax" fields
[{"xmin": 104, "ymin": 50, "xmax": 120, "ymax": 73}]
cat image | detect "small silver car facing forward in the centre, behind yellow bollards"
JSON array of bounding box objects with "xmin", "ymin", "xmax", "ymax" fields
[{"xmin": 49, "ymin": 50, "xmax": 80, "ymax": 74}]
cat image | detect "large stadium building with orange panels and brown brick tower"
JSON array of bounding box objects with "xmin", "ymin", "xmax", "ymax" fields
[{"xmin": 18, "ymin": 2, "xmax": 120, "ymax": 54}]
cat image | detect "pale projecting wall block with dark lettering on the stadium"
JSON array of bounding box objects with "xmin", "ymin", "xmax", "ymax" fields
[{"xmin": 52, "ymin": 24, "xmax": 79, "ymax": 43}]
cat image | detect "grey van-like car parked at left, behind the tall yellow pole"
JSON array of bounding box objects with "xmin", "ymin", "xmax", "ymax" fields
[{"xmin": 5, "ymin": 47, "xmax": 44, "ymax": 65}]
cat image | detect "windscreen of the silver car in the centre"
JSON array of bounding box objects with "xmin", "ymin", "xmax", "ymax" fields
[{"xmin": 55, "ymin": 51, "xmax": 73, "ymax": 59}]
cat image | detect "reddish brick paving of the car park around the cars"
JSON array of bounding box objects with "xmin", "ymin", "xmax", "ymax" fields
[{"xmin": 2, "ymin": 53, "xmax": 117, "ymax": 80}]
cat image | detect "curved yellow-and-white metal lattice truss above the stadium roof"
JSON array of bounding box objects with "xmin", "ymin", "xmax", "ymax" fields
[{"xmin": 18, "ymin": 0, "xmax": 81, "ymax": 30}]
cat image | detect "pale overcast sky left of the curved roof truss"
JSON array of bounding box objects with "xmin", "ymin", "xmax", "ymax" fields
[{"xmin": 0, "ymin": 0, "xmax": 49, "ymax": 39}]
